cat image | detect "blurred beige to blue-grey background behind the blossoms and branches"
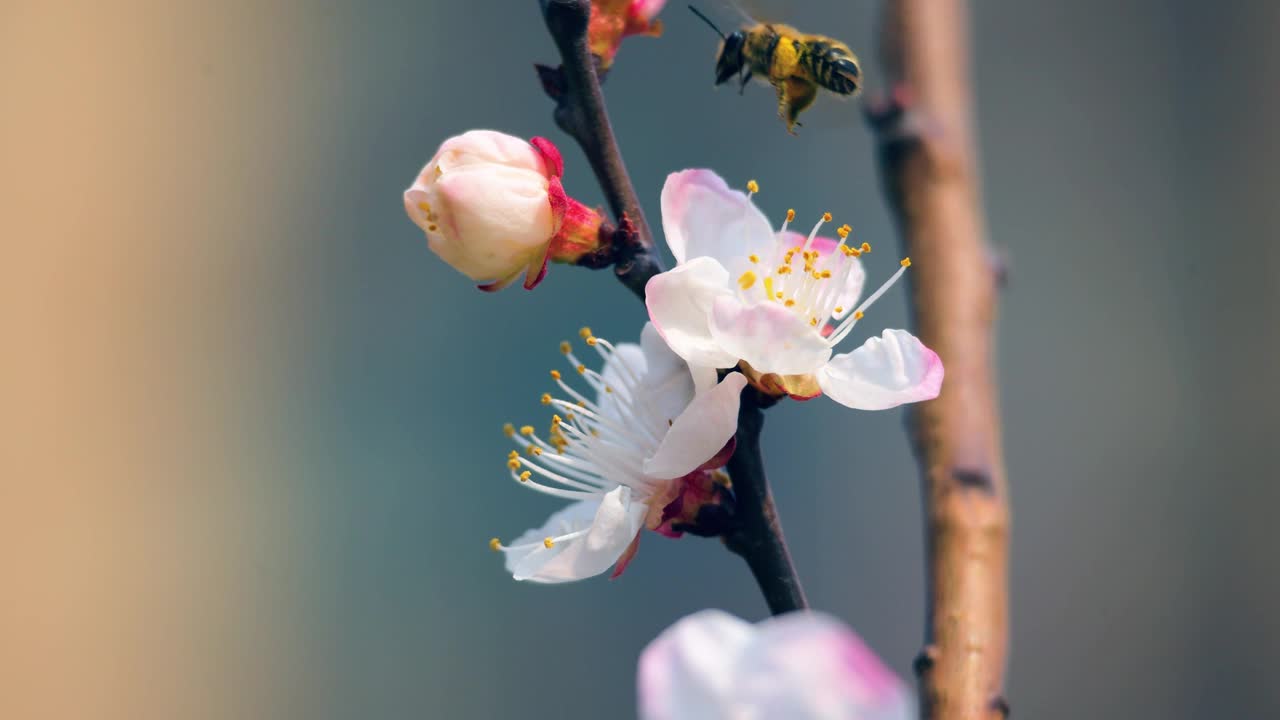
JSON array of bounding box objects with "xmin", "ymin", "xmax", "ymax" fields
[{"xmin": 0, "ymin": 0, "xmax": 1280, "ymax": 719}]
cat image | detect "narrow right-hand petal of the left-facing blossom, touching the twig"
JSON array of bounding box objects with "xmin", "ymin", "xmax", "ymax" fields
[{"xmin": 644, "ymin": 373, "xmax": 746, "ymax": 480}]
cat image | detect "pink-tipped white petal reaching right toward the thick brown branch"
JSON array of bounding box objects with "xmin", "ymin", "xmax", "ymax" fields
[{"xmin": 818, "ymin": 329, "xmax": 943, "ymax": 410}]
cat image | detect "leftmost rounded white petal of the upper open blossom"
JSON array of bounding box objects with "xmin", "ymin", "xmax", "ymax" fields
[{"xmin": 645, "ymin": 258, "xmax": 737, "ymax": 368}]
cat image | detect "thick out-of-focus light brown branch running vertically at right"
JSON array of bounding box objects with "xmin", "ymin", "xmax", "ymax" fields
[{"xmin": 868, "ymin": 0, "xmax": 1009, "ymax": 720}]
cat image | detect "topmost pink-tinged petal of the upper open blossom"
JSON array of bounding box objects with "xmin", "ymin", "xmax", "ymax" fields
[{"xmin": 662, "ymin": 169, "xmax": 777, "ymax": 267}]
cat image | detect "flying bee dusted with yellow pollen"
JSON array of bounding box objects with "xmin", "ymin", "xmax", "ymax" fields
[{"xmin": 689, "ymin": 5, "xmax": 861, "ymax": 135}]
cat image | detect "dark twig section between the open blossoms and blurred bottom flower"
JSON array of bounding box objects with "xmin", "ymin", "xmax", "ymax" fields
[{"xmin": 724, "ymin": 388, "xmax": 809, "ymax": 615}]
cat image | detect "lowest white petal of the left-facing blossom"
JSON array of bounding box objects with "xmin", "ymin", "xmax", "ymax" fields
[{"xmin": 507, "ymin": 486, "xmax": 646, "ymax": 583}]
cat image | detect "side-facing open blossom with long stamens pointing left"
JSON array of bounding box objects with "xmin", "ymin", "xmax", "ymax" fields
[{"xmin": 489, "ymin": 324, "xmax": 746, "ymax": 583}]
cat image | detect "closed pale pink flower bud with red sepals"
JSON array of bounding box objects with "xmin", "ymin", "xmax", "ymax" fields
[{"xmin": 404, "ymin": 129, "xmax": 611, "ymax": 291}]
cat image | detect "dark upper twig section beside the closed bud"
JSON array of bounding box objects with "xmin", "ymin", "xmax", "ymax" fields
[{"xmin": 539, "ymin": 0, "xmax": 663, "ymax": 300}]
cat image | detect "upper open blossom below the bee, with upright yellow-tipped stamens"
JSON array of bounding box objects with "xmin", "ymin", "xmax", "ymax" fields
[{"xmin": 645, "ymin": 170, "xmax": 943, "ymax": 410}]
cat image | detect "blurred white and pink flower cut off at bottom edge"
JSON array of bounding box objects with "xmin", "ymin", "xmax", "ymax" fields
[{"xmin": 637, "ymin": 610, "xmax": 914, "ymax": 720}]
